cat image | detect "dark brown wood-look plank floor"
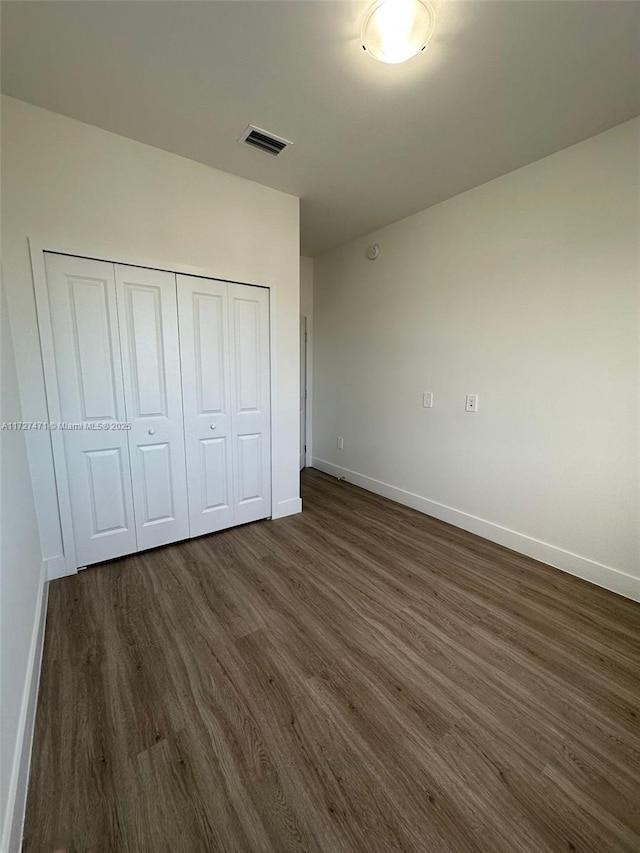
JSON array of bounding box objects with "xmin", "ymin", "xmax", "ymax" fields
[{"xmin": 24, "ymin": 471, "xmax": 640, "ymax": 853}]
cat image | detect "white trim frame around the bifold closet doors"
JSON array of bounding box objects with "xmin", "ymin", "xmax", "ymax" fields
[{"xmin": 27, "ymin": 236, "xmax": 277, "ymax": 580}]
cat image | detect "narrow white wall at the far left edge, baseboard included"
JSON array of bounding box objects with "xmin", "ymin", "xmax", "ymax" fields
[{"xmin": 0, "ymin": 276, "xmax": 46, "ymax": 853}]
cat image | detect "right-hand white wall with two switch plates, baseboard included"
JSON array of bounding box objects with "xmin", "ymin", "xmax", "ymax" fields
[{"xmin": 314, "ymin": 119, "xmax": 640, "ymax": 598}]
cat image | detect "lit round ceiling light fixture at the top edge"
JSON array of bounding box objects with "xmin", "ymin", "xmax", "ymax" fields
[{"xmin": 361, "ymin": 0, "xmax": 436, "ymax": 65}]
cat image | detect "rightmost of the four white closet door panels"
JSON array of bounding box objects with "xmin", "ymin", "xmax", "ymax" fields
[{"xmin": 229, "ymin": 284, "xmax": 271, "ymax": 524}]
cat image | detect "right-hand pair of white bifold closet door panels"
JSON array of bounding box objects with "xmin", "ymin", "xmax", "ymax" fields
[{"xmin": 177, "ymin": 275, "xmax": 271, "ymax": 536}]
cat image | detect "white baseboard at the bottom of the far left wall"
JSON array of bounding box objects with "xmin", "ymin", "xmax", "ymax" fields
[{"xmin": 0, "ymin": 561, "xmax": 49, "ymax": 853}]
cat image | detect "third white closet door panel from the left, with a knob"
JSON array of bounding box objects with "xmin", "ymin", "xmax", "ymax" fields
[{"xmin": 177, "ymin": 275, "xmax": 234, "ymax": 536}]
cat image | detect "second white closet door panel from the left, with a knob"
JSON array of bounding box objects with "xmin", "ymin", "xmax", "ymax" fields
[{"xmin": 115, "ymin": 265, "xmax": 189, "ymax": 550}]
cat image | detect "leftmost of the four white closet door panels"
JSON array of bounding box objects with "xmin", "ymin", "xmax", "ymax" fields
[{"xmin": 45, "ymin": 253, "xmax": 137, "ymax": 566}]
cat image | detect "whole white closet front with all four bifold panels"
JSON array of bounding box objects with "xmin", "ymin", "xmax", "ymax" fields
[{"xmin": 39, "ymin": 252, "xmax": 271, "ymax": 566}]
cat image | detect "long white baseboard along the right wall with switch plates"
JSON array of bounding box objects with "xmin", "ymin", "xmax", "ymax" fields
[{"xmin": 313, "ymin": 457, "xmax": 640, "ymax": 601}]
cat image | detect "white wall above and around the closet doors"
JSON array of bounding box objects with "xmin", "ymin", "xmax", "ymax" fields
[{"xmin": 2, "ymin": 97, "xmax": 300, "ymax": 574}]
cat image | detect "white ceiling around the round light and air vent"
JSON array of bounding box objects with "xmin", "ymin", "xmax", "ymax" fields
[{"xmin": 2, "ymin": 0, "xmax": 640, "ymax": 256}]
